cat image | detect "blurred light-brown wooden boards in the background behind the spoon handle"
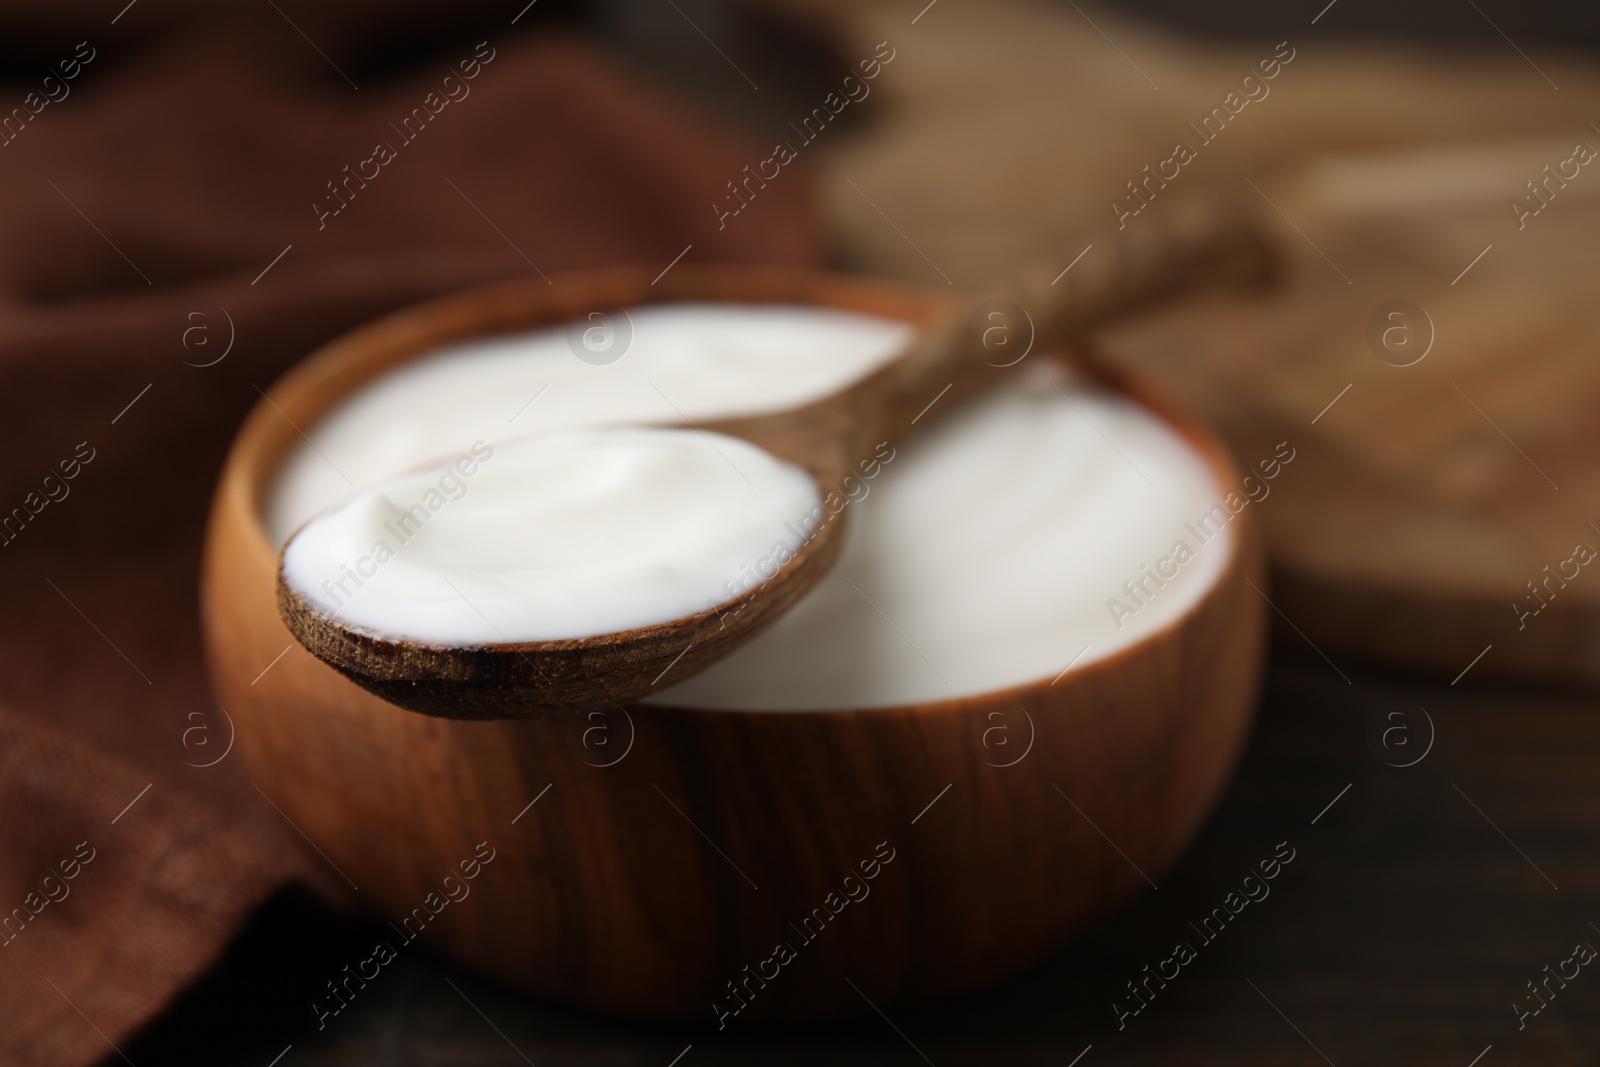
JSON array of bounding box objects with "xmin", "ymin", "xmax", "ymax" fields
[{"xmin": 800, "ymin": 0, "xmax": 1600, "ymax": 681}]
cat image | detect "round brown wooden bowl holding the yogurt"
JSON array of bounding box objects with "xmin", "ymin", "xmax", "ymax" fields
[{"xmin": 202, "ymin": 266, "xmax": 1266, "ymax": 1021}]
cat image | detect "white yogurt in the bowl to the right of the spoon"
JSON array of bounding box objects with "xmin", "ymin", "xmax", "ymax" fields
[{"xmin": 650, "ymin": 368, "xmax": 1234, "ymax": 710}]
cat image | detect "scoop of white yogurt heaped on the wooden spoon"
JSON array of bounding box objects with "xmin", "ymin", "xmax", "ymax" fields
[{"xmin": 283, "ymin": 427, "xmax": 819, "ymax": 646}]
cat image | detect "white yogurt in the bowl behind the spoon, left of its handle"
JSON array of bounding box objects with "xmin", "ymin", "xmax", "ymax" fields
[{"xmin": 264, "ymin": 304, "xmax": 912, "ymax": 545}]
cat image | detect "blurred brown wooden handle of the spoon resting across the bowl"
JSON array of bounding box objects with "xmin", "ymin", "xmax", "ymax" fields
[{"xmin": 850, "ymin": 205, "xmax": 1280, "ymax": 451}]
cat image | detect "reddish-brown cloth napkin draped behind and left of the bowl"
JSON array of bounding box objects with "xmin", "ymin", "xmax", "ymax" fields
[{"xmin": 0, "ymin": 12, "xmax": 818, "ymax": 1067}]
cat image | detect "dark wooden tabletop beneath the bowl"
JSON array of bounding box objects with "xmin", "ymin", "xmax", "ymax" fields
[{"xmin": 121, "ymin": 635, "xmax": 1600, "ymax": 1067}]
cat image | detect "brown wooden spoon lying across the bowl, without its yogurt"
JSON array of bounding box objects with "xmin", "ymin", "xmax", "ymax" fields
[{"xmin": 277, "ymin": 202, "xmax": 1277, "ymax": 718}]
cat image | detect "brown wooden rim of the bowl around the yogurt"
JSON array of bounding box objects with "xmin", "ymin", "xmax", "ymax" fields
[{"xmin": 214, "ymin": 264, "xmax": 1270, "ymax": 717}]
